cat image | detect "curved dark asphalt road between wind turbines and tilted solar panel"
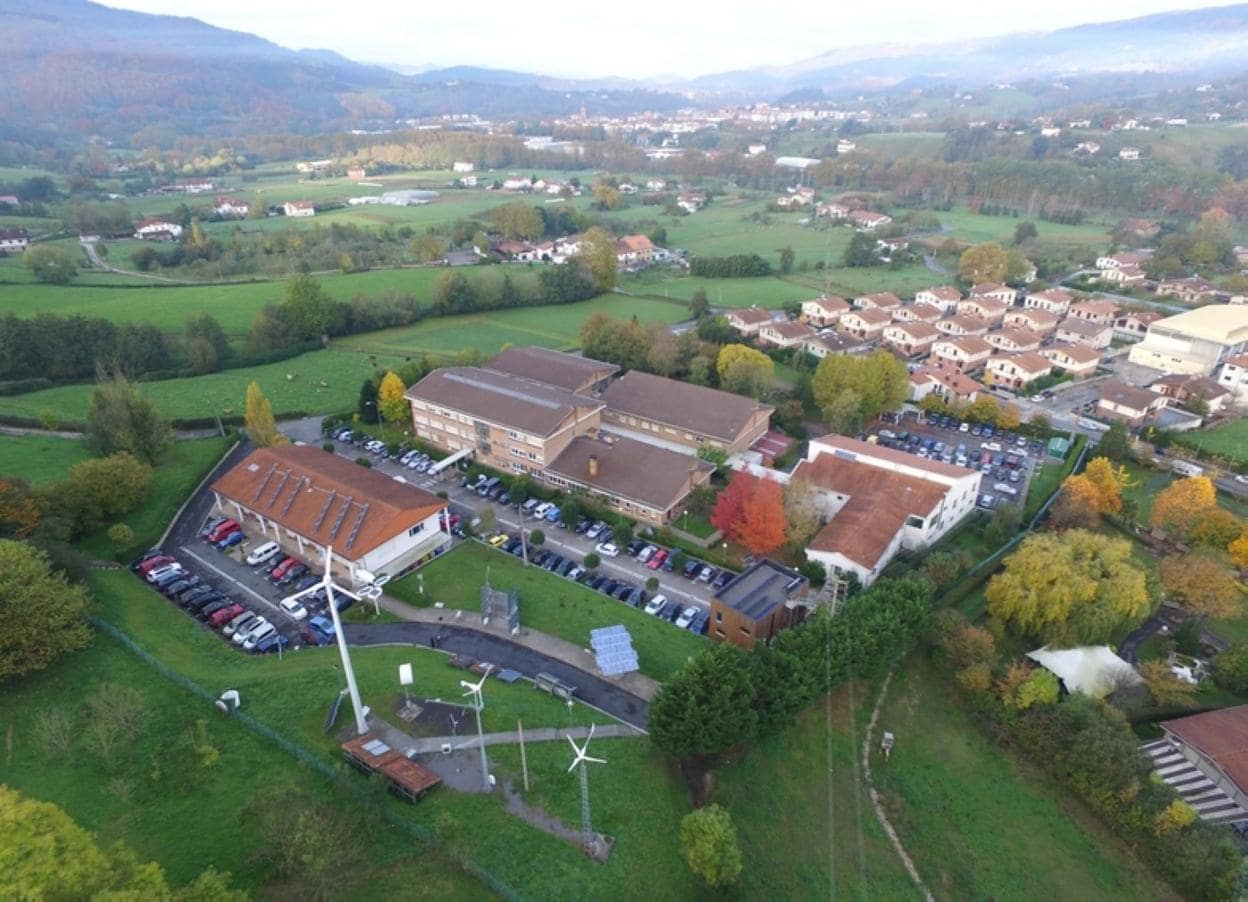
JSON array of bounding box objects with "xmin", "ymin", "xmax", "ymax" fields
[{"xmin": 343, "ymin": 623, "xmax": 649, "ymax": 730}]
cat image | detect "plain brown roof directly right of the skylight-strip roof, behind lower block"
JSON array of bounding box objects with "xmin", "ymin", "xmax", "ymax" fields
[{"xmin": 603, "ymin": 369, "xmax": 773, "ymax": 442}]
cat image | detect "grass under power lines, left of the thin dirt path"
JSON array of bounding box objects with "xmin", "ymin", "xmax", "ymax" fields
[{"xmin": 711, "ymin": 685, "xmax": 919, "ymax": 900}]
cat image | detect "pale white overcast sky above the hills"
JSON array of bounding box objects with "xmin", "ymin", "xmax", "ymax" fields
[{"xmin": 105, "ymin": 0, "xmax": 1217, "ymax": 79}]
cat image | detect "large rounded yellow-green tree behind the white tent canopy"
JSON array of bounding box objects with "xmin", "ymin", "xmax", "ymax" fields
[{"xmin": 986, "ymin": 529, "xmax": 1149, "ymax": 644}]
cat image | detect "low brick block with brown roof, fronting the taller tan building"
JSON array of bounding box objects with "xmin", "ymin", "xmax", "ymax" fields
[{"xmin": 543, "ymin": 432, "xmax": 715, "ymax": 526}]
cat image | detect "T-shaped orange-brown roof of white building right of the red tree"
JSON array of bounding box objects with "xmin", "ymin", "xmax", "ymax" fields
[{"xmin": 792, "ymin": 449, "xmax": 966, "ymax": 570}]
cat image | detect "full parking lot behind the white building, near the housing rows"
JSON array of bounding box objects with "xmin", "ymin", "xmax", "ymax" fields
[{"xmin": 872, "ymin": 417, "xmax": 1047, "ymax": 510}]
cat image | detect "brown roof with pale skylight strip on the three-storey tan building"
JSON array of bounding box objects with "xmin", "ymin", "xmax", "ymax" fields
[{"xmin": 406, "ymin": 367, "xmax": 603, "ymax": 435}]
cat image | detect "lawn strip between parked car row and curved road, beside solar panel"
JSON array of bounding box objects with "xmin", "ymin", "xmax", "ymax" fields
[{"xmin": 387, "ymin": 541, "xmax": 706, "ymax": 680}]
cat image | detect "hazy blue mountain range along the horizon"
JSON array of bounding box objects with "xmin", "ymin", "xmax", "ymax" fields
[{"xmin": 0, "ymin": 0, "xmax": 1248, "ymax": 145}]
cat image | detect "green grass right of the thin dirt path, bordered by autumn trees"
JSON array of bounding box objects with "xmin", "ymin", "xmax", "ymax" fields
[{"xmin": 873, "ymin": 655, "xmax": 1169, "ymax": 900}]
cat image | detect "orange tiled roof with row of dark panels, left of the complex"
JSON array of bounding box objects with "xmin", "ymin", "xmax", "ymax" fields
[{"xmin": 212, "ymin": 445, "xmax": 447, "ymax": 560}]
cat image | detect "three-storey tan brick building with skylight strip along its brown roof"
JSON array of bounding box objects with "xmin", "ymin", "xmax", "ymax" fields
[{"xmin": 407, "ymin": 367, "xmax": 604, "ymax": 475}]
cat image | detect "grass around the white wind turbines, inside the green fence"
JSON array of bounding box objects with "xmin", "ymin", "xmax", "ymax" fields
[{"xmin": 79, "ymin": 571, "xmax": 695, "ymax": 900}]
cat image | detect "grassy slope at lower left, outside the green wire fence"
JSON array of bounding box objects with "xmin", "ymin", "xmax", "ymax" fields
[{"xmin": 0, "ymin": 611, "xmax": 489, "ymax": 900}]
